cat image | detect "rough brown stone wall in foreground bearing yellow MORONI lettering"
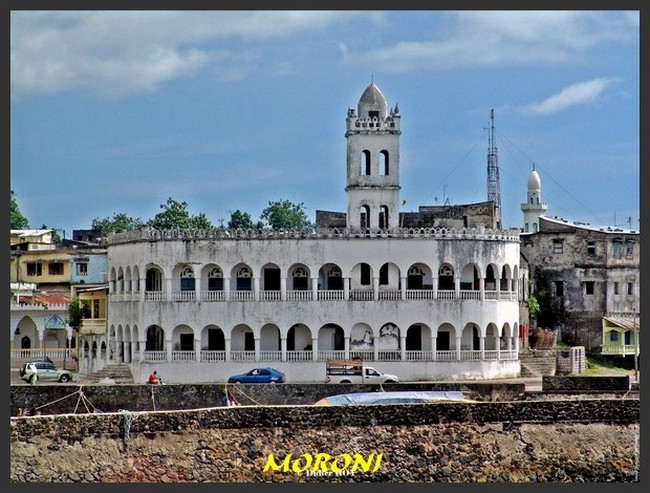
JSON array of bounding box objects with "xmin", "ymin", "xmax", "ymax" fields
[{"xmin": 10, "ymin": 400, "xmax": 640, "ymax": 483}]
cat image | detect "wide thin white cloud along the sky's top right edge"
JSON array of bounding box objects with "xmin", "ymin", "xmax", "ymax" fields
[{"xmin": 349, "ymin": 11, "xmax": 638, "ymax": 72}]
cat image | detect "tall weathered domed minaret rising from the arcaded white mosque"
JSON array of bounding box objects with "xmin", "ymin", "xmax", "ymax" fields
[{"xmin": 345, "ymin": 82, "xmax": 402, "ymax": 229}]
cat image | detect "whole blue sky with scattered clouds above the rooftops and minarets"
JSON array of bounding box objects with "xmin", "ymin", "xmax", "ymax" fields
[{"xmin": 10, "ymin": 11, "xmax": 640, "ymax": 238}]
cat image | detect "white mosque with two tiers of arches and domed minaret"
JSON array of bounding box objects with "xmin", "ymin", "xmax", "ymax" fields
[{"xmin": 105, "ymin": 83, "xmax": 530, "ymax": 383}]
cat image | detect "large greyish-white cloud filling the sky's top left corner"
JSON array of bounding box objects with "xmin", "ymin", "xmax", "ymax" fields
[{"xmin": 10, "ymin": 11, "xmax": 354, "ymax": 98}]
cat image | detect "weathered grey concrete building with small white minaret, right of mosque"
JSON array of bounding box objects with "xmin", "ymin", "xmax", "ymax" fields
[{"xmin": 521, "ymin": 169, "xmax": 641, "ymax": 352}]
